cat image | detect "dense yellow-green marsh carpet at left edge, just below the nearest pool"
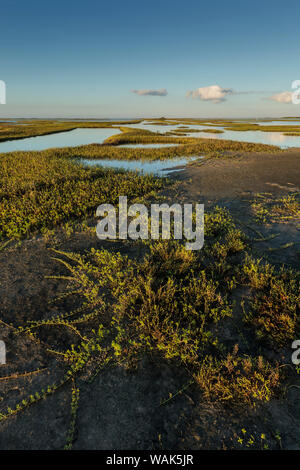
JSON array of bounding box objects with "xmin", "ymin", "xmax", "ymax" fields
[{"xmin": 0, "ymin": 152, "xmax": 164, "ymax": 240}]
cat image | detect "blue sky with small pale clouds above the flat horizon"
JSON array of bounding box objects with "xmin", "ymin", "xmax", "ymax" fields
[{"xmin": 0, "ymin": 0, "xmax": 300, "ymax": 118}]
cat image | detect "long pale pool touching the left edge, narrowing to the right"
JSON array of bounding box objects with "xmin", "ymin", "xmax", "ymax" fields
[{"xmin": 0, "ymin": 128, "xmax": 120, "ymax": 153}]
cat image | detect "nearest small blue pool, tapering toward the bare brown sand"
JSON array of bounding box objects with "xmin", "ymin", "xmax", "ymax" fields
[{"xmin": 80, "ymin": 157, "xmax": 203, "ymax": 176}]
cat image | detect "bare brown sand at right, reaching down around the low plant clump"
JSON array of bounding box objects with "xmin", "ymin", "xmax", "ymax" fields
[{"xmin": 167, "ymin": 149, "xmax": 300, "ymax": 269}]
